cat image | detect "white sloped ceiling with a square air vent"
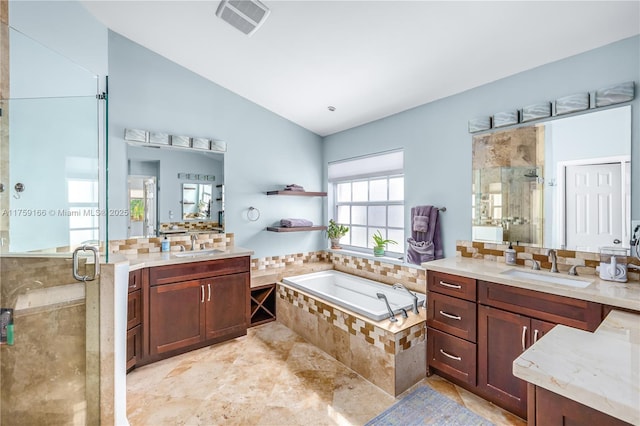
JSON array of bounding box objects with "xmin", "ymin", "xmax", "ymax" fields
[{"xmin": 82, "ymin": 0, "xmax": 640, "ymax": 136}]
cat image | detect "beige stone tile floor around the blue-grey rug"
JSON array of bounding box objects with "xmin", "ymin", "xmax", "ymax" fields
[{"xmin": 127, "ymin": 322, "xmax": 526, "ymax": 426}]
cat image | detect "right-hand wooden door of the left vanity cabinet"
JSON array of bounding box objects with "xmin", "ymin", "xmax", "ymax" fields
[{"xmin": 203, "ymin": 272, "xmax": 250, "ymax": 339}]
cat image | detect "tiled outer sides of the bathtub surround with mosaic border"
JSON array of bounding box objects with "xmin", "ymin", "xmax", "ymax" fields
[{"xmin": 276, "ymin": 283, "xmax": 426, "ymax": 396}]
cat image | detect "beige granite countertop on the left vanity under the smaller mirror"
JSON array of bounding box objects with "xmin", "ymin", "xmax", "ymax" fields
[{"xmin": 109, "ymin": 246, "xmax": 253, "ymax": 271}]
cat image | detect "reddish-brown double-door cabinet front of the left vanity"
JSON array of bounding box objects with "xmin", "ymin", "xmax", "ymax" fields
[{"xmin": 144, "ymin": 256, "xmax": 250, "ymax": 363}]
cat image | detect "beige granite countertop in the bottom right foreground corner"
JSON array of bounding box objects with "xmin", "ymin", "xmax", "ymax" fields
[{"xmin": 513, "ymin": 310, "xmax": 640, "ymax": 425}]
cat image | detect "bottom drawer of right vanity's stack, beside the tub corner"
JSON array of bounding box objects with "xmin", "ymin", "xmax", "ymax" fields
[{"xmin": 427, "ymin": 327, "xmax": 476, "ymax": 386}]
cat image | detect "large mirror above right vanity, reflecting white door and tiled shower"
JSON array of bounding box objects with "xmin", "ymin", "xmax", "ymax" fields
[{"xmin": 472, "ymin": 105, "xmax": 631, "ymax": 252}]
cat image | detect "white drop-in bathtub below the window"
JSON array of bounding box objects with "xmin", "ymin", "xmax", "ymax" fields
[{"xmin": 282, "ymin": 270, "xmax": 426, "ymax": 321}]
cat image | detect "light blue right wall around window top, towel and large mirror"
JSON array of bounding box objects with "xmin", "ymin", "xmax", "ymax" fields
[{"xmin": 323, "ymin": 36, "xmax": 640, "ymax": 256}]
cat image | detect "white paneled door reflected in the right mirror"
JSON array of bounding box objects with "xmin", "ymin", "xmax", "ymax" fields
[{"xmin": 565, "ymin": 163, "xmax": 624, "ymax": 252}]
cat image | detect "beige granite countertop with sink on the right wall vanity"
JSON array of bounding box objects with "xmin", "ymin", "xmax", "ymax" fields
[{"xmin": 421, "ymin": 257, "xmax": 640, "ymax": 312}]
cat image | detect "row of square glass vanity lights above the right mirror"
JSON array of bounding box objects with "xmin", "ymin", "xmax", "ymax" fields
[{"xmin": 469, "ymin": 81, "xmax": 635, "ymax": 133}]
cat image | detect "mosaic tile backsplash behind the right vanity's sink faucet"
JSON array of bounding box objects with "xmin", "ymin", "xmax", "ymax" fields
[{"xmin": 456, "ymin": 240, "xmax": 640, "ymax": 281}]
